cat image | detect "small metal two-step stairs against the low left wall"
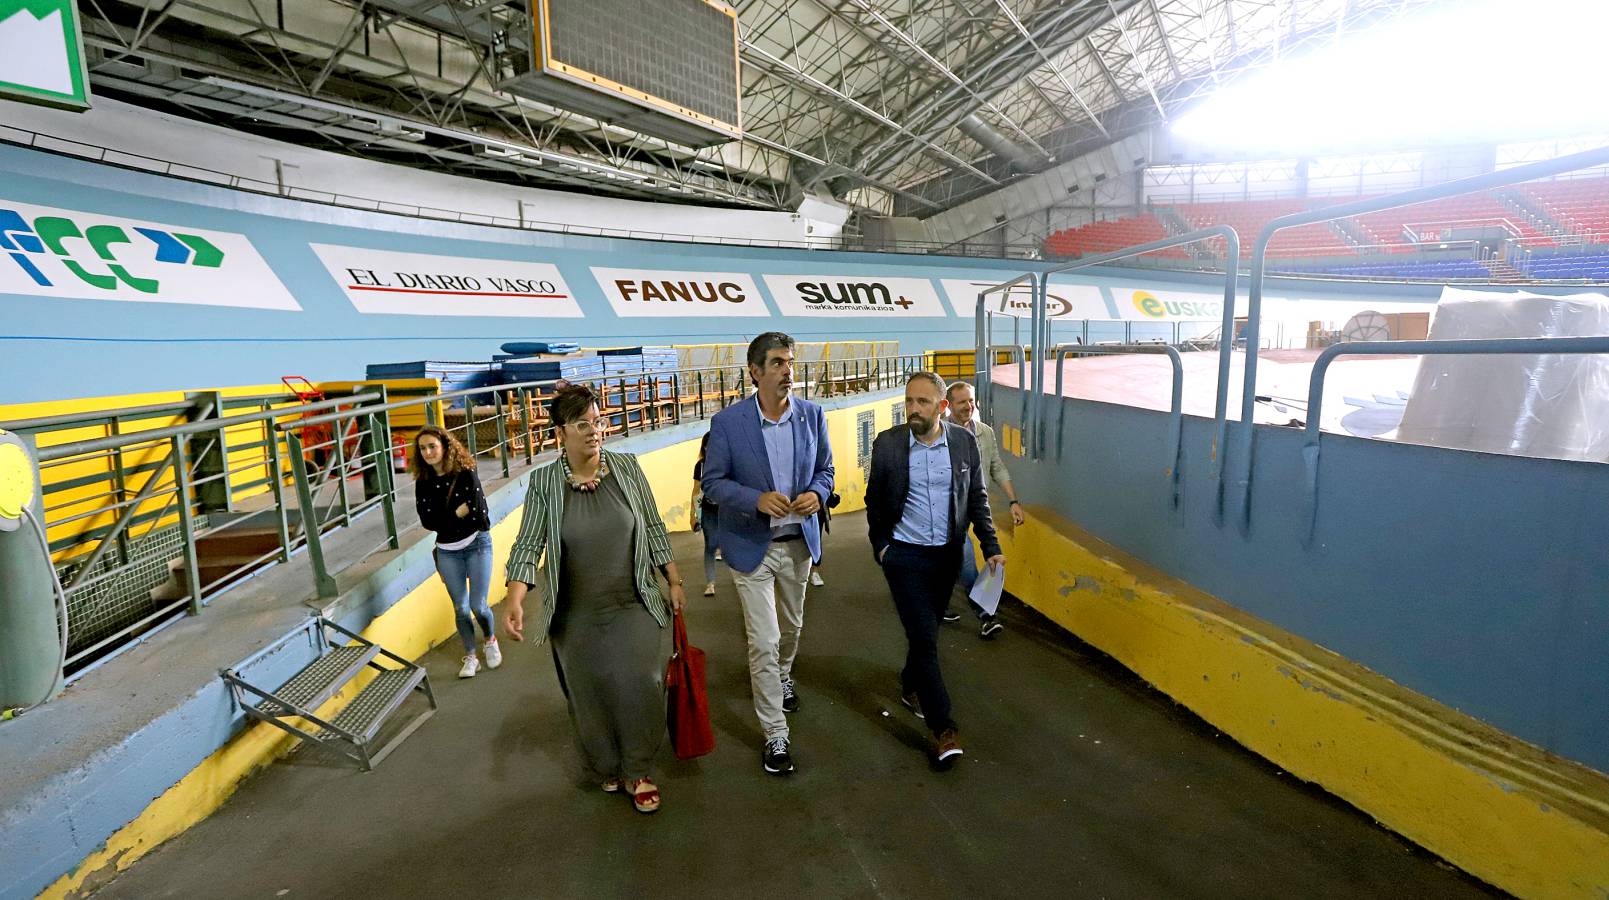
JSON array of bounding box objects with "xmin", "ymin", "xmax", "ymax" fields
[{"xmin": 222, "ymin": 615, "xmax": 436, "ymax": 771}]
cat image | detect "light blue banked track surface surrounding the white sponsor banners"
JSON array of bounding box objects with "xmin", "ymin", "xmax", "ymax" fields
[{"xmin": 0, "ymin": 147, "xmax": 1437, "ymax": 403}]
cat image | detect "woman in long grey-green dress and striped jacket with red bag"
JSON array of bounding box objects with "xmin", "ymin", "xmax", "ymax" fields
[{"xmin": 504, "ymin": 385, "xmax": 685, "ymax": 813}]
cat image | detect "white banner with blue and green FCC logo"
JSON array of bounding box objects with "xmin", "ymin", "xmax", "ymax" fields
[{"xmin": 0, "ymin": 200, "xmax": 301, "ymax": 311}]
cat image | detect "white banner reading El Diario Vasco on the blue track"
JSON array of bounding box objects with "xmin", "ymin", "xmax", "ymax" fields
[{"xmin": 311, "ymin": 243, "xmax": 581, "ymax": 319}]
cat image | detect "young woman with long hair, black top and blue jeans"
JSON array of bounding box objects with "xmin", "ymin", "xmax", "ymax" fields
[{"xmin": 409, "ymin": 425, "xmax": 502, "ymax": 678}]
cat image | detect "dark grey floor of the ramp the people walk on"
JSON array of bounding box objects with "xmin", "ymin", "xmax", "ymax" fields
[{"xmin": 98, "ymin": 515, "xmax": 1496, "ymax": 898}]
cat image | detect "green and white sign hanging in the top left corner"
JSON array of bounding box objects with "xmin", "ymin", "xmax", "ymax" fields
[{"xmin": 0, "ymin": 0, "xmax": 90, "ymax": 111}]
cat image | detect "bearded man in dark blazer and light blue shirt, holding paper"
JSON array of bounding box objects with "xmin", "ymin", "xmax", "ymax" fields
[{"xmin": 866, "ymin": 372, "xmax": 1006, "ymax": 766}]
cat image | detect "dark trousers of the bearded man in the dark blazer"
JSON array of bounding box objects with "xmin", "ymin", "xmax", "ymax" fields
[{"xmin": 883, "ymin": 541, "xmax": 961, "ymax": 734}]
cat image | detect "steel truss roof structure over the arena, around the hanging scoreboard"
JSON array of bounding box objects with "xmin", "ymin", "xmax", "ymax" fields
[{"xmin": 47, "ymin": 0, "xmax": 1435, "ymax": 216}]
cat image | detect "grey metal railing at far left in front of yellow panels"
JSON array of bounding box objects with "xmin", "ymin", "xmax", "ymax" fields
[{"xmin": 0, "ymin": 393, "xmax": 380, "ymax": 676}]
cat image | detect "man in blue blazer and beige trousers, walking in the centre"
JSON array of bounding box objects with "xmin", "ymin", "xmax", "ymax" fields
[{"xmin": 703, "ymin": 332, "xmax": 836, "ymax": 774}]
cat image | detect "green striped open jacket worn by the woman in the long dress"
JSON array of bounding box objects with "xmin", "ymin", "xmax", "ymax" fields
[{"xmin": 507, "ymin": 451, "xmax": 671, "ymax": 644}]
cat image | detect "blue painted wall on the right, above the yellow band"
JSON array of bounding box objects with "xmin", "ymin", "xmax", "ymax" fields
[{"xmin": 996, "ymin": 388, "xmax": 1609, "ymax": 771}]
